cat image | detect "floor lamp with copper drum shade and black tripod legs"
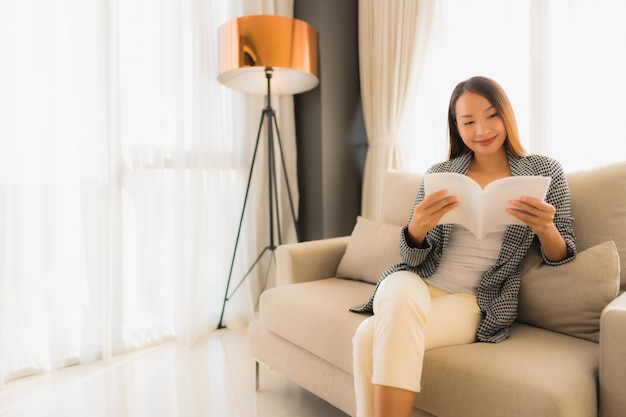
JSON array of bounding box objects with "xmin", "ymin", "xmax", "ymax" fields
[{"xmin": 217, "ymin": 15, "xmax": 319, "ymax": 329}]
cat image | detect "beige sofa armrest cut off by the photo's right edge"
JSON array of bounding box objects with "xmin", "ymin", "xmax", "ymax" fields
[{"xmin": 600, "ymin": 293, "xmax": 626, "ymax": 417}]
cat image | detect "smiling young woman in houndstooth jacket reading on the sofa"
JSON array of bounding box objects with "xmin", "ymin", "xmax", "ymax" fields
[{"xmin": 351, "ymin": 77, "xmax": 576, "ymax": 417}]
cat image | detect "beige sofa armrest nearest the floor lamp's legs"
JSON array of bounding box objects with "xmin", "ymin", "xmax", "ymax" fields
[{"xmin": 276, "ymin": 236, "xmax": 350, "ymax": 286}]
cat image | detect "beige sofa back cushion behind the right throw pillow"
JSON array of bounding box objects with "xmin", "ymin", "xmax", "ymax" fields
[{"xmin": 567, "ymin": 162, "xmax": 626, "ymax": 291}]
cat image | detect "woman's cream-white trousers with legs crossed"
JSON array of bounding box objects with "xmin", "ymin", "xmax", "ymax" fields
[{"xmin": 353, "ymin": 271, "xmax": 481, "ymax": 417}]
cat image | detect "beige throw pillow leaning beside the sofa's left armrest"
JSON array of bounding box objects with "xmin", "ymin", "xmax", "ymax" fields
[{"xmin": 337, "ymin": 216, "xmax": 402, "ymax": 284}]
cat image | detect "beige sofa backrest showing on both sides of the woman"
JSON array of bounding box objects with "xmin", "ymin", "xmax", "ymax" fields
[{"xmin": 380, "ymin": 162, "xmax": 626, "ymax": 292}]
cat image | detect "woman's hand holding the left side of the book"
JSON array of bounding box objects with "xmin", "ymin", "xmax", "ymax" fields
[{"xmin": 408, "ymin": 190, "xmax": 459, "ymax": 247}]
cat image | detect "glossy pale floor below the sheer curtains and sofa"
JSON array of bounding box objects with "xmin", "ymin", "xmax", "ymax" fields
[{"xmin": 0, "ymin": 329, "xmax": 347, "ymax": 417}]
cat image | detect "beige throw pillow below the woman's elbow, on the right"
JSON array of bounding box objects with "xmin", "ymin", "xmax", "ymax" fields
[{"xmin": 518, "ymin": 241, "xmax": 620, "ymax": 342}]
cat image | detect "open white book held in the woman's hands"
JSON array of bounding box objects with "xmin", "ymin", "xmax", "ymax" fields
[{"xmin": 424, "ymin": 172, "xmax": 550, "ymax": 239}]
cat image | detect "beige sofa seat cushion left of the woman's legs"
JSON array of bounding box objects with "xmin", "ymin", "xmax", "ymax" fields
[{"xmin": 259, "ymin": 278, "xmax": 374, "ymax": 374}]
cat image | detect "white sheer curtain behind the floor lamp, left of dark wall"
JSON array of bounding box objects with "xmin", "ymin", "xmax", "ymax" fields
[{"xmin": 0, "ymin": 0, "xmax": 297, "ymax": 385}]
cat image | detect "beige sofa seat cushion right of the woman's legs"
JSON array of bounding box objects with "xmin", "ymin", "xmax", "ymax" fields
[{"xmin": 416, "ymin": 323, "xmax": 599, "ymax": 417}]
